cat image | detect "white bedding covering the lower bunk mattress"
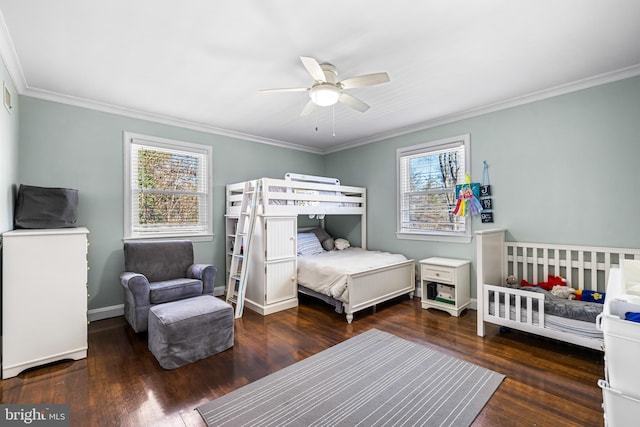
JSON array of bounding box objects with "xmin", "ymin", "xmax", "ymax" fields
[{"xmin": 298, "ymin": 247, "xmax": 407, "ymax": 302}]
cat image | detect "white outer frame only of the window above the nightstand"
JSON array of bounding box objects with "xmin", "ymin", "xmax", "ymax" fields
[{"xmin": 396, "ymin": 134, "xmax": 472, "ymax": 243}]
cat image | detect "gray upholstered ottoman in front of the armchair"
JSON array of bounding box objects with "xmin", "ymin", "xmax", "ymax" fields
[{"xmin": 149, "ymin": 295, "xmax": 234, "ymax": 369}]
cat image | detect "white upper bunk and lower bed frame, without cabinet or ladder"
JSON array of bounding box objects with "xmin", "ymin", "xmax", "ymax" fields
[{"xmin": 226, "ymin": 176, "xmax": 415, "ymax": 323}]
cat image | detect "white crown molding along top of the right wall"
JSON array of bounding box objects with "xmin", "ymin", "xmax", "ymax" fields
[{"xmin": 323, "ymin": 64, "xmax": 640, "ymax": 154}]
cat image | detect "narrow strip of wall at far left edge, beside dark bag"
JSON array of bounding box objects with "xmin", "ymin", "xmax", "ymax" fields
[{"xmin": 0, "ymin": 59, "xmax": 20, "ymax": 233}]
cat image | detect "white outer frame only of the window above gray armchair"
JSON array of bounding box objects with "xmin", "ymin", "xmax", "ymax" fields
[{"xmin": 123, "ymin": 132, "xmax": 213, "ymax": 241}]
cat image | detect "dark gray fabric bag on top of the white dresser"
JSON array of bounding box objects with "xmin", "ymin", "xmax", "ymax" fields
[{"xmin": 13, "ymin": 185, "xmax": 78, "ymax": 228}]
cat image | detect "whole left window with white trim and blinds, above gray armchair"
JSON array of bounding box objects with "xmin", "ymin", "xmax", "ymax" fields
[{"xmin": 124, "ymin": 132, "xmax": 213, "ymax": 240}]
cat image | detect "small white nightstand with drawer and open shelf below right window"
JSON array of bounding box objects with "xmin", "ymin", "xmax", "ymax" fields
[{"xmin": 420, "ymin": 257, "xmax": 471, "ymax": 317}]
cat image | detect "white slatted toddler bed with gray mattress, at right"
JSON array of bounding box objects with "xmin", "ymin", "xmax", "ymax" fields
[{"xmin": 476, "ymin": 229, "xmax": 640, "ymax": 350}]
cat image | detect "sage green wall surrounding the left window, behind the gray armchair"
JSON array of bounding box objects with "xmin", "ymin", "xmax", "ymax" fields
[{"xmin": 18, "ymin": 97, "xmax": 323, "ymax": 310}]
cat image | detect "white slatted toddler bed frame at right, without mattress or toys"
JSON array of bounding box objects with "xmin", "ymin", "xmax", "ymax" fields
[{"xmin": 476, "ymin": 229, "xmax": 640, "ymax": 350}]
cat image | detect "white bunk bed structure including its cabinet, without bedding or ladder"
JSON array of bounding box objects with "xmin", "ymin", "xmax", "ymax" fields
[{"xmin": 226, "ymin": 174, "xmax": 415, "ymax": 323}]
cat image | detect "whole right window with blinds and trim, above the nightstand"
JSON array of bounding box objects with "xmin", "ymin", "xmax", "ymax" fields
[{"xmin": 396, "ymin": 135, "xmax": 471, "ymax": 243}]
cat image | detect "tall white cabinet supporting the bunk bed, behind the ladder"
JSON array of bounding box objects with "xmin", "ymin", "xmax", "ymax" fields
[{"xmin": 226, "ymin": 215, "xmax": 298, "ymax": 315}]
